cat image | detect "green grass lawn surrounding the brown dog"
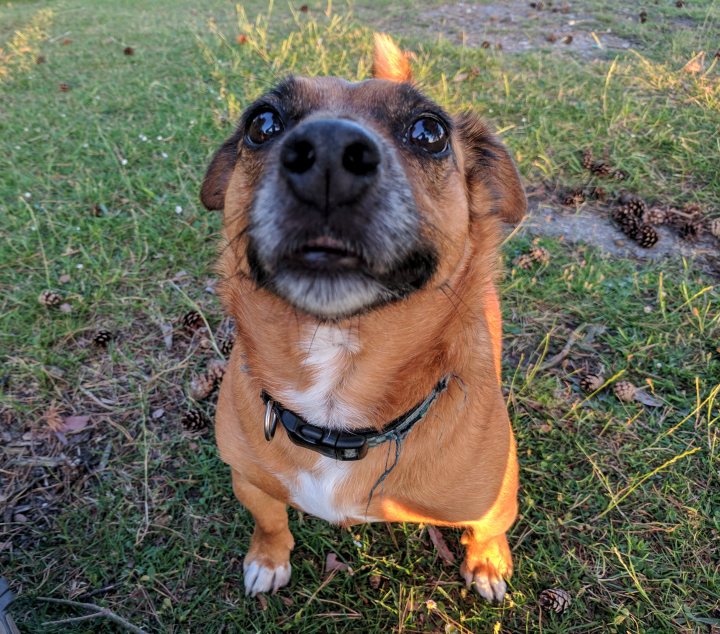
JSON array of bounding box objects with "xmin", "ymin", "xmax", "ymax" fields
[{"xmin": 0, "ymin": 0, "xmax": 720, "ymax": 633}]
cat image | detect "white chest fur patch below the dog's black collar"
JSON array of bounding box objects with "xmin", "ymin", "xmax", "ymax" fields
[{"xmin": 283, "ymin": 456, "xmax": 375, "ymax": 523}]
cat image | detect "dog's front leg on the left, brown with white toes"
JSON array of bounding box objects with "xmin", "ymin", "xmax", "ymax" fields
[{"xmin": 232, "ymin": 469, "xmax": 295, "ymax": 597}]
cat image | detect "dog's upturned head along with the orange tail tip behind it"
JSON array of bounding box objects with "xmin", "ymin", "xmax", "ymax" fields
[{"xmin": 201, "ymin": 36, "xmax": 526, "ymax": 319}]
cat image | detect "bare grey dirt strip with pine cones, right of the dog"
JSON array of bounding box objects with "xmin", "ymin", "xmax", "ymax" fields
[{"xmin": 519, "ymin": 199, "xmax": 720, "ymax": 275}]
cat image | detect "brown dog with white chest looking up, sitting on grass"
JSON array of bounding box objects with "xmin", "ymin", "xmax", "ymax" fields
[{"xmin": 201, "ymin": 35, "xmax": 526, "ymax": 601}]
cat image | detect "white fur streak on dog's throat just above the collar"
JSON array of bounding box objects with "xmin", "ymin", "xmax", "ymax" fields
[{"xmin": 280, "ymin": 325, "xmax": 366, "ymax": 429}]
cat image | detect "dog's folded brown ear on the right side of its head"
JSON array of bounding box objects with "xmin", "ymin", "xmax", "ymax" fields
[{"xmin": 457, "ymin": 112, "xmax": 527, "ymax": 222}]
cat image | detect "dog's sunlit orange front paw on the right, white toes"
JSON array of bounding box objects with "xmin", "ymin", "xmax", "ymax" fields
[{"xmin": 460, "ymin": 533, "xmax": 512, "ymax": 603}]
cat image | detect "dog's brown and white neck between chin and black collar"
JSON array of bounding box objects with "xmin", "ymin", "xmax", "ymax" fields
[{"xmin": 223, "ymin": 239, "xmax": 493, "ymax": 430}]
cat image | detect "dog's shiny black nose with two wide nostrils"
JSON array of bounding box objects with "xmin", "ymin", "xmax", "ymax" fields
[{"xmin": 280, "ymin": 119, "xmax": 381, "ymax": 213}]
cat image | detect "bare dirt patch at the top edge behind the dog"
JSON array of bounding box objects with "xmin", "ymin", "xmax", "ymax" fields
[{"xmin": 368, "ymin": 0, "xmax": 632, "ymax": 59}]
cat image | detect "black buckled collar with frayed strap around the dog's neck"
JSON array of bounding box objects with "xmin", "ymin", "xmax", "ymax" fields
[{"xmin": 261, "ymin": 376, "xmax": 450, "ymax": 460}]
